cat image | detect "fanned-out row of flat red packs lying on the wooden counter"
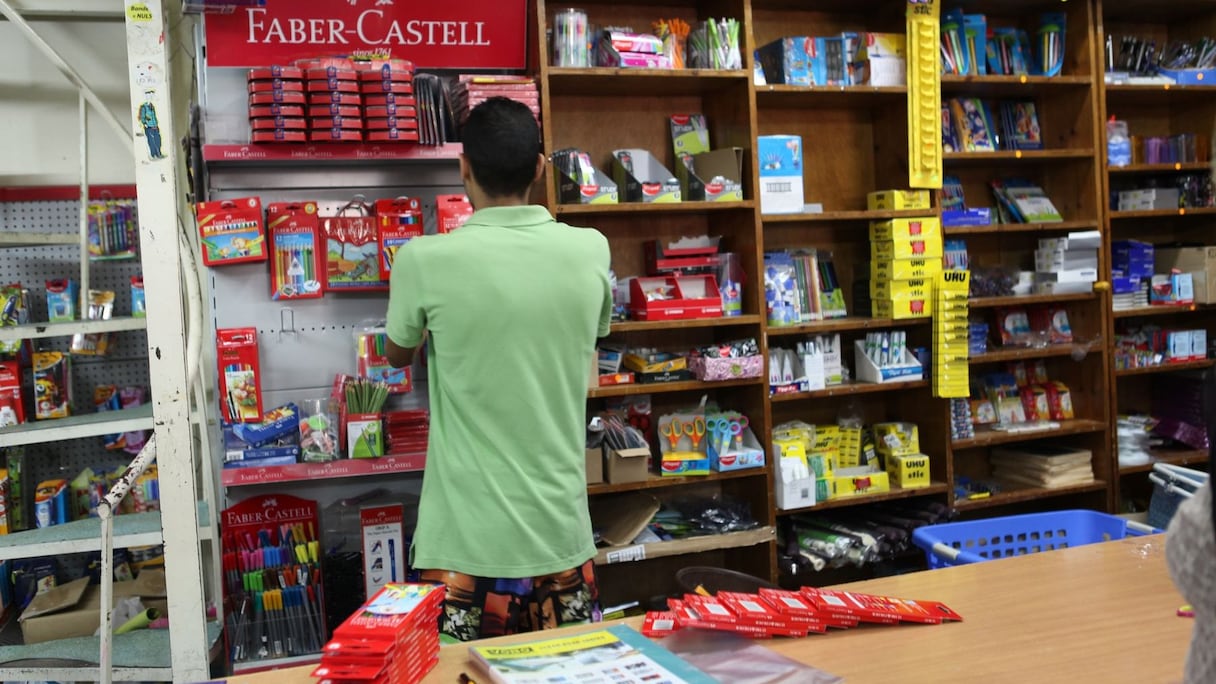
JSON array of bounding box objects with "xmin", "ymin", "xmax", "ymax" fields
[{"xmin": 642, "ymin": 587, "xmax": 962, "ymax": 639}]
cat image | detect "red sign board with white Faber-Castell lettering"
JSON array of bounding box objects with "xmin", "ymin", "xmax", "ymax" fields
[{"xmin": 206, "ymin": 0, "xmax": 528, "ymax": 69}]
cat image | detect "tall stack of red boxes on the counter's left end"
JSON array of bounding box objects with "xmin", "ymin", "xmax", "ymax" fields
[{"xmin": 313, "ymin": 584, "xmax": 444, "ymax": 684}]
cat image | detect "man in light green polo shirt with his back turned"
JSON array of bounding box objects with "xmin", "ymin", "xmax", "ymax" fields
[{"xmin": 388, "ymin": 97, "xmax": 612, "ymax": 640}]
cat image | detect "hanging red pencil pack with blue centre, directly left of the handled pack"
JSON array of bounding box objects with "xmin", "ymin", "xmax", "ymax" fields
[{"xmin": 266, "ymin": 202, "xmax": 325, "ymax": 299}]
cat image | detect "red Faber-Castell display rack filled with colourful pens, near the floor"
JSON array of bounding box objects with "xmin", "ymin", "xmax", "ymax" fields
[{"xmin": 223, "ymin": 494, "xmax": 327, "ymax": 662}]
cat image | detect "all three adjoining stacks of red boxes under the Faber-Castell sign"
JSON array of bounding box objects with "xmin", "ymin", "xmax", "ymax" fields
[{"xmin": 248, "ymin": 57, "xmax": 418, "ymax": 142}]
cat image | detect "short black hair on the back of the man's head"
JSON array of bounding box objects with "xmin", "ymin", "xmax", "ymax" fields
[{"xmin": 461, "ymin": 97, "xmax": 540, "ymax": 197}]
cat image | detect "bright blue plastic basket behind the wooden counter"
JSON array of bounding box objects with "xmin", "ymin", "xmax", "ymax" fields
[{"xmin": 912, "ymin": 510, "xmax": 1161, "ymax": 568}]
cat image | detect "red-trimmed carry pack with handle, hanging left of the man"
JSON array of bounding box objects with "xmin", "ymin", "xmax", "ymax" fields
[{"xmin": 321, "ymin": 196, "xmax": 388, "ymax": 292}]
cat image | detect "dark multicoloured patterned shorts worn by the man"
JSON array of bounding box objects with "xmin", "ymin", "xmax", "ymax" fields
[{"xmin": 421, "ymin": 561, "xmax": 599, "ymax": 644}]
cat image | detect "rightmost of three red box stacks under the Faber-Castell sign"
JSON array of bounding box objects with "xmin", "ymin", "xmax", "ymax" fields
[{"xmin": 359, "ymin": 60, "xmax": 418, "ymax": 142}]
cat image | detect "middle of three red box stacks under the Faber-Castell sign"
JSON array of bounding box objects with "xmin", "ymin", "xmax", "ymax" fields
[{"xmin": 304, "ymin": 60, "xmax": 364, "ymax": 142}]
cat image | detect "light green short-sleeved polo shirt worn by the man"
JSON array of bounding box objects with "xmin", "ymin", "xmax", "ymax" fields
[{"xmin": 388, "ymin": 206, "xmax": 612, "ymax": 578}]
